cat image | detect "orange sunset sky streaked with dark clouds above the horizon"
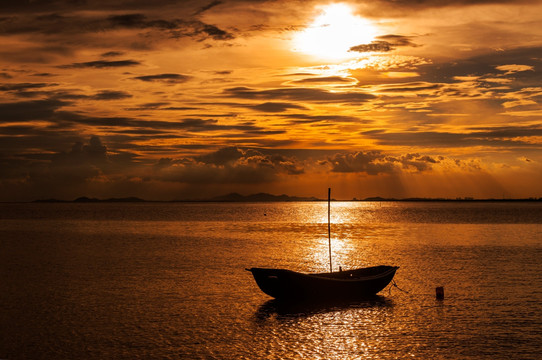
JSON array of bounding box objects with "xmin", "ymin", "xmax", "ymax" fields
[{"xmin": 0, "ymin": 0, "xmax": 542, "ymax": 201}]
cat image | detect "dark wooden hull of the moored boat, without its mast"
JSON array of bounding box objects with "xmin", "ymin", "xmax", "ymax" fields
[{"xmin": 247, "ymin": 265, "xmax": 398, "ymax": 300}]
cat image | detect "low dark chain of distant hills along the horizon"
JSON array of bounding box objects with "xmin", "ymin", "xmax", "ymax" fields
[{"xmin": 33, "ymin": 193, "xmax": 542, "ymax": 203}]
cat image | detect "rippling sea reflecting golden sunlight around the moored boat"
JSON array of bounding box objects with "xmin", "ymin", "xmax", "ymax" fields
[{"xmin": 0, "ymin": 201, "xmax": 542, "ymax": 360}]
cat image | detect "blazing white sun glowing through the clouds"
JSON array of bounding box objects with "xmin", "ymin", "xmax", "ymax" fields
[{"xmin": 293, "ymin": 4, "xmax": 376, "ymax": 60}]
